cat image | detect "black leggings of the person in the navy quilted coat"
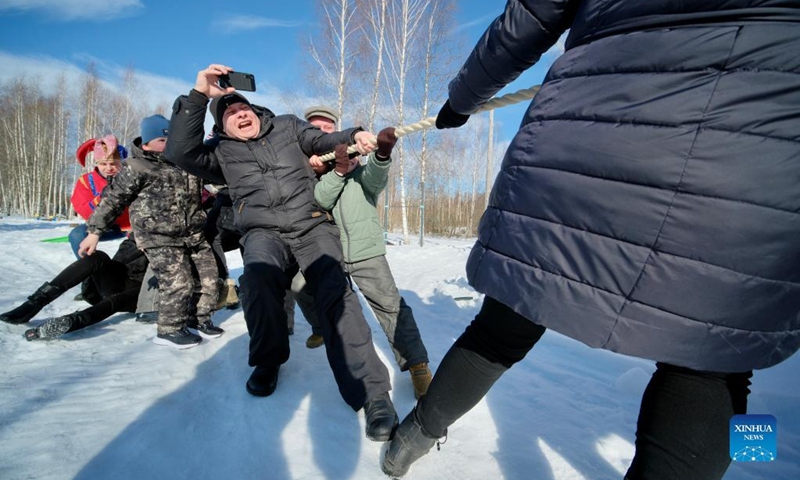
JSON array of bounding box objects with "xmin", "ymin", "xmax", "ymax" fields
[{"xmin": 434, "ymin": 297, "xmax": 752, "ymax": 480}]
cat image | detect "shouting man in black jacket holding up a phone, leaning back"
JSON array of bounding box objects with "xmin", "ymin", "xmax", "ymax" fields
[{"xmin": 166, "ymin": 65, "xmax": 397, "ymax": 441}]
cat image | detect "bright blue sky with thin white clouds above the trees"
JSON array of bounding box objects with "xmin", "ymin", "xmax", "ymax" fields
[{"xmin": 0, "ymin": 0, "xmax": 553, "ymax": 140}]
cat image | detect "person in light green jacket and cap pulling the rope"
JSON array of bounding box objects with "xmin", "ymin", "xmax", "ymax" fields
[{"xmin": 305, "ymin": 107, "xmax": 431, "ymax": 398}]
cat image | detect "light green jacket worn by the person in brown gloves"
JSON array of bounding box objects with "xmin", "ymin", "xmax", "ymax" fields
[{"xmin": 314, "ymin": 153, "xmax": 392, "ymax": 263}]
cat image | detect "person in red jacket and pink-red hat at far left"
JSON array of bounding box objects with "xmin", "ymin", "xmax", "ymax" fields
[{"xmin": 69, "ymin": 135, "xmax": 131, "ymax": 258}]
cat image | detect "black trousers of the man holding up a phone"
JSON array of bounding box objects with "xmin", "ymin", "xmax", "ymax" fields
[{"xmin": 239, "ymin": 223, "xmax": 391, "ymax": 410}]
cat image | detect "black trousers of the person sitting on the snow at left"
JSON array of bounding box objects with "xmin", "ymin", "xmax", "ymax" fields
[{"xmin": 50, "ymin": 250, "xmax": 141, "ymax": 332}]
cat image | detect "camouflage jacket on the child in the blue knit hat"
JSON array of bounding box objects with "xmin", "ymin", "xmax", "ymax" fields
[{"xmin": 86, "ymin": 138, "xmax": 206, "ymax": 250}]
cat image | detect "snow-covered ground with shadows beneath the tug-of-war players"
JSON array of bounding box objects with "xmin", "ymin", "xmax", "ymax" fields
[{"xmin": 0, "ymin": 218, "xmax": 800, "ymax": 480}]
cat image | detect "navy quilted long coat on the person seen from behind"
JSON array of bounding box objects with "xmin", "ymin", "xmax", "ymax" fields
[{"xmin": 456, "ymin": 0, "xmax": 800, "ymax": 372}]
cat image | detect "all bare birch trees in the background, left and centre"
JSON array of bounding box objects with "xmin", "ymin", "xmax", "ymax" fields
[{"xmin": 0, "ymin": 0, "xmax": 510, "ymax": 243}]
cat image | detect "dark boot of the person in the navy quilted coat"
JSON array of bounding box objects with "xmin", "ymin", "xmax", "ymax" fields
[{"xmin": 381, "ymin": 408, "xmax": 438, "ymax": 478}]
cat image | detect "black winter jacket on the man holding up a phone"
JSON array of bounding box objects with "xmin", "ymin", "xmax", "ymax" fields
[{"xmin": 165, "ymin": 90, "xmax": 361, "ymax": 237}]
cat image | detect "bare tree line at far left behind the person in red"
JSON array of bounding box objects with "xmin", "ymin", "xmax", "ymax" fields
[{"xmin": 0, "ymin": 65, "xmax": 166, "ymax": 218}]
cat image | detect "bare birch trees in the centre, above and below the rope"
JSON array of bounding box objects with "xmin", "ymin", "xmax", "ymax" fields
[{"xmin": 304, "ymin": 0, "xmax": 502, "ymax": 243}]
